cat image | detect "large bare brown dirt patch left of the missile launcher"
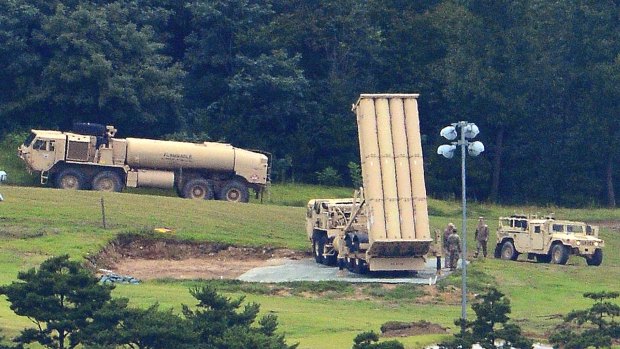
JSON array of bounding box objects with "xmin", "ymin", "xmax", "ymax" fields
[{"xmin": 88, "ymin": 236, "xmax": 306, "ymax": 280}]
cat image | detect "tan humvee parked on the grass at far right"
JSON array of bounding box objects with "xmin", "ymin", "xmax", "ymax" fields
[{"xmin": 495, "ymin": 215, "xmax": 605, "ymax": 266}]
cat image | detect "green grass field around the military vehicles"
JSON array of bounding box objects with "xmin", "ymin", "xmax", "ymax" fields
[{"xmin": 0, "ymin": 185, "xmax": 620, "ymax": 349}]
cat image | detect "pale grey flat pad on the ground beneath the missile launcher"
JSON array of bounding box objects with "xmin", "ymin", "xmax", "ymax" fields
[{"xmin": 238, "ymin": 258, "xmax": 460, "ymax": 285}]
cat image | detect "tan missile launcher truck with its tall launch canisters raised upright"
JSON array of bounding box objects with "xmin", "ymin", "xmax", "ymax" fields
[{"xmin": 306, "ymin": 94, "xmax": 433, "ymax": 273}]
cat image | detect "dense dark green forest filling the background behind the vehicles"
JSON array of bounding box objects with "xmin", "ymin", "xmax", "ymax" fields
[{"xmin": 0, "ymin": 0, "xmax": 620, "ymax": 206}]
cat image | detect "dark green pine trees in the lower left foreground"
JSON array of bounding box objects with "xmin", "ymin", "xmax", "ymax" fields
[{"xmin": 0, "ymin": 255, "xmax": 297, "ymax": 349}]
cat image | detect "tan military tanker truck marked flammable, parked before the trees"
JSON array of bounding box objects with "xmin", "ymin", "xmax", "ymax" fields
[{"xmin": 18, "ymin": 123, "xmax": 269, "ymax": 202}]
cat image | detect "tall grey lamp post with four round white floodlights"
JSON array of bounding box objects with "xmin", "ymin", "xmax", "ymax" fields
[{"xmin": 437, "ymin": 121, "xmax": 484, "ymax": 321}]
